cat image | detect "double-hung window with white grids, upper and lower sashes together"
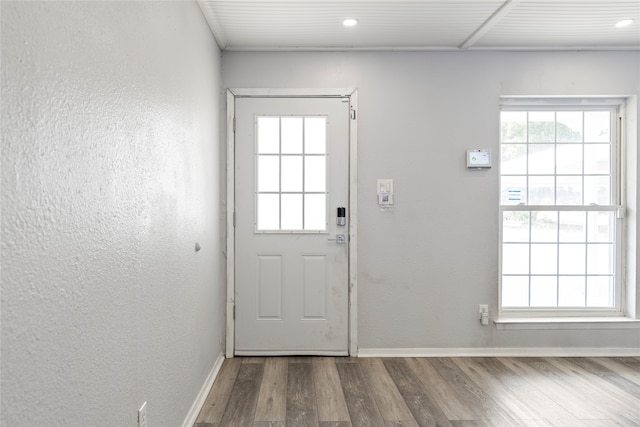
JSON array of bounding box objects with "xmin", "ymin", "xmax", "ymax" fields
[{"xmin": 500, "ymin": 102, "xmax": 623, "ymax": 316}]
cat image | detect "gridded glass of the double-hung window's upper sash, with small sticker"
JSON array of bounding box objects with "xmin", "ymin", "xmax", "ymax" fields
[{"xmin": 501, "ymin": 111, "xmax": 616, "ymax": 205}]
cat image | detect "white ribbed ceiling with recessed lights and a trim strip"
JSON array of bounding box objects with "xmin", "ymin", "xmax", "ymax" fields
[{"xmin": 198, "ymin": 0, "xmax": 640, "ymax": 50}]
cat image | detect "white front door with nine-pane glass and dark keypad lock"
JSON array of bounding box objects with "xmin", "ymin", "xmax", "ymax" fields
[{"xmin": 235, "ymin": 98, "xmax": 349, "ymax": 355}]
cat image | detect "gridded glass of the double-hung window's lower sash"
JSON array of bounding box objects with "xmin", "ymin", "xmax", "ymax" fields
[{"xmin": 502, "ymin": 210, "xmax": 616, "ymax": 308}]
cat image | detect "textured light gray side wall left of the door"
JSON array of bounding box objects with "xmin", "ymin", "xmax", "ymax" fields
[{"xmin": 1, "ymin": 1, "xmax": 224, "ymax": 426}]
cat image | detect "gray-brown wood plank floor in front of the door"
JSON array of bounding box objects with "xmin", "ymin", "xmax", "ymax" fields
[{"xmin": 194, "ymin": 357, "xmax": 640, "ymax": 427}]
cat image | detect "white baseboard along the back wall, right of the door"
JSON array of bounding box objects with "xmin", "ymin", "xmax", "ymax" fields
[{"xmin": 358, "ymin": 347, "xmax": 640, "ymax": 357}]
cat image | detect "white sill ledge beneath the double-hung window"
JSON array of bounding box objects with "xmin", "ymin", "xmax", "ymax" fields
[{"xmin": 493, "ymin": 317, "xmax": 640, "ymax": 330}]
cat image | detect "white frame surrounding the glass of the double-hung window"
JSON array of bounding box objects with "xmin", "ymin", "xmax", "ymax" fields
[{"xmin": 498, "ymin": 98, "xmax": 625, "ymax": 318}]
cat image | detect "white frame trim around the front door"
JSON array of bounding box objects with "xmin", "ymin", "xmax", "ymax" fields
[{"xmin": 226, "ymin": 88, "xmax": 358, "ymax": 358}]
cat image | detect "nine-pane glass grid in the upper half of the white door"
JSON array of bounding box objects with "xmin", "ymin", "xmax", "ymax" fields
[{"xmin": 256, "ymin": 116, "xmax": 328, "ymax": 233}]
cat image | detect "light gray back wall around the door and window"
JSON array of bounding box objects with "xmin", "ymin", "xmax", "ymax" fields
[{"xmin": 222, "ymin": 52, "xmax": 640, "ymax": 348}]
